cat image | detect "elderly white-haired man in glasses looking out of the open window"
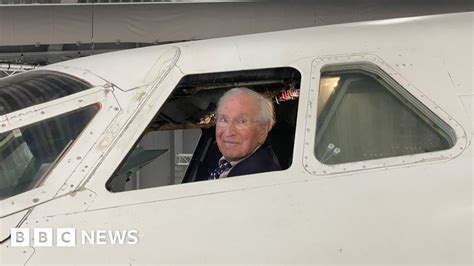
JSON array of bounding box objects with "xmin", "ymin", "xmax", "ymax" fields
[{"xmin": 208, "ymin": 88, "xmax": 281, "ymax": 179}]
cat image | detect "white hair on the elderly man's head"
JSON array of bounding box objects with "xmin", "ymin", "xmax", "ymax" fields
[{"xmin": 217, "ymin": 87, "xmax": 275, "ymax": 129}]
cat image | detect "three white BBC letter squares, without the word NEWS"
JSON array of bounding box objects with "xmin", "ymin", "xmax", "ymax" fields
[{"xmin": 10, "ymin": 228, "xmax": 76, "ymax": 247}]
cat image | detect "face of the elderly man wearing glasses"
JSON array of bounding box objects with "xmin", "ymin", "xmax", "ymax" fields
[{"xmin": 216, "ymin": 94, "xmax": 269, "ymax": 161}]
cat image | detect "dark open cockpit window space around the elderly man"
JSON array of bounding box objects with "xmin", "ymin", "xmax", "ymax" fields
[{"xmin": 106, "ymin": 67, "xmax": 301, "ymax": 192}]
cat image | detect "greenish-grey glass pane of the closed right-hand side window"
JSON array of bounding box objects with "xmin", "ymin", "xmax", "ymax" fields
[{"xmin": 315, "ymin": 71, "xmax": 453, "ymax": 164}]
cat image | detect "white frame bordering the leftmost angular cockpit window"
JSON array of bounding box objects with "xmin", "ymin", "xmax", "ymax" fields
[{"xmin": 0, "ymin": 81, "xmax": 121, "ymax": 218}]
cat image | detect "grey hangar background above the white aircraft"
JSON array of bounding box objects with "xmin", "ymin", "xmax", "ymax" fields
[{"xmin": 0, "ymin": 0, "xmax": 474, "ymax": 70}]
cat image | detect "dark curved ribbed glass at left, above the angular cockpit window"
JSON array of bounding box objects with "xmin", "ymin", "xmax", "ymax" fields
[{"xmin": 0, "ymin": 70, "xmax": 91, "ymax": 115}]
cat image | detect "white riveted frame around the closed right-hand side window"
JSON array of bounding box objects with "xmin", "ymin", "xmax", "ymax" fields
[{"xmin": 303, "ymin": 54, "xmax": 467, "ymax": 176}]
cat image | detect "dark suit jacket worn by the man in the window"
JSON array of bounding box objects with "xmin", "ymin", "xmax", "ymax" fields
[{"xmin": 195, "ymin": 144, "xmax": 281, "ymax": 181}]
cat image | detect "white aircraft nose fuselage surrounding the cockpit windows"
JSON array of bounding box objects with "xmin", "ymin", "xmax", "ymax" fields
[{"xmin": 0, "ymin": 13, "xmax": 474, "ymax": 265}]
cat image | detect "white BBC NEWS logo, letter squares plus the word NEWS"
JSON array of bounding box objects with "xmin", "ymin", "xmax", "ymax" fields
[{"xmin": 10, "ymin": 228, "xmax": 138, "ymax": 247}]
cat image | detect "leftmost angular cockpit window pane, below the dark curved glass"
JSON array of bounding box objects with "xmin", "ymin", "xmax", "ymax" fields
[{"xmin": 0, "ymin": 105, "xmax": 98, "ymax": 200}]
